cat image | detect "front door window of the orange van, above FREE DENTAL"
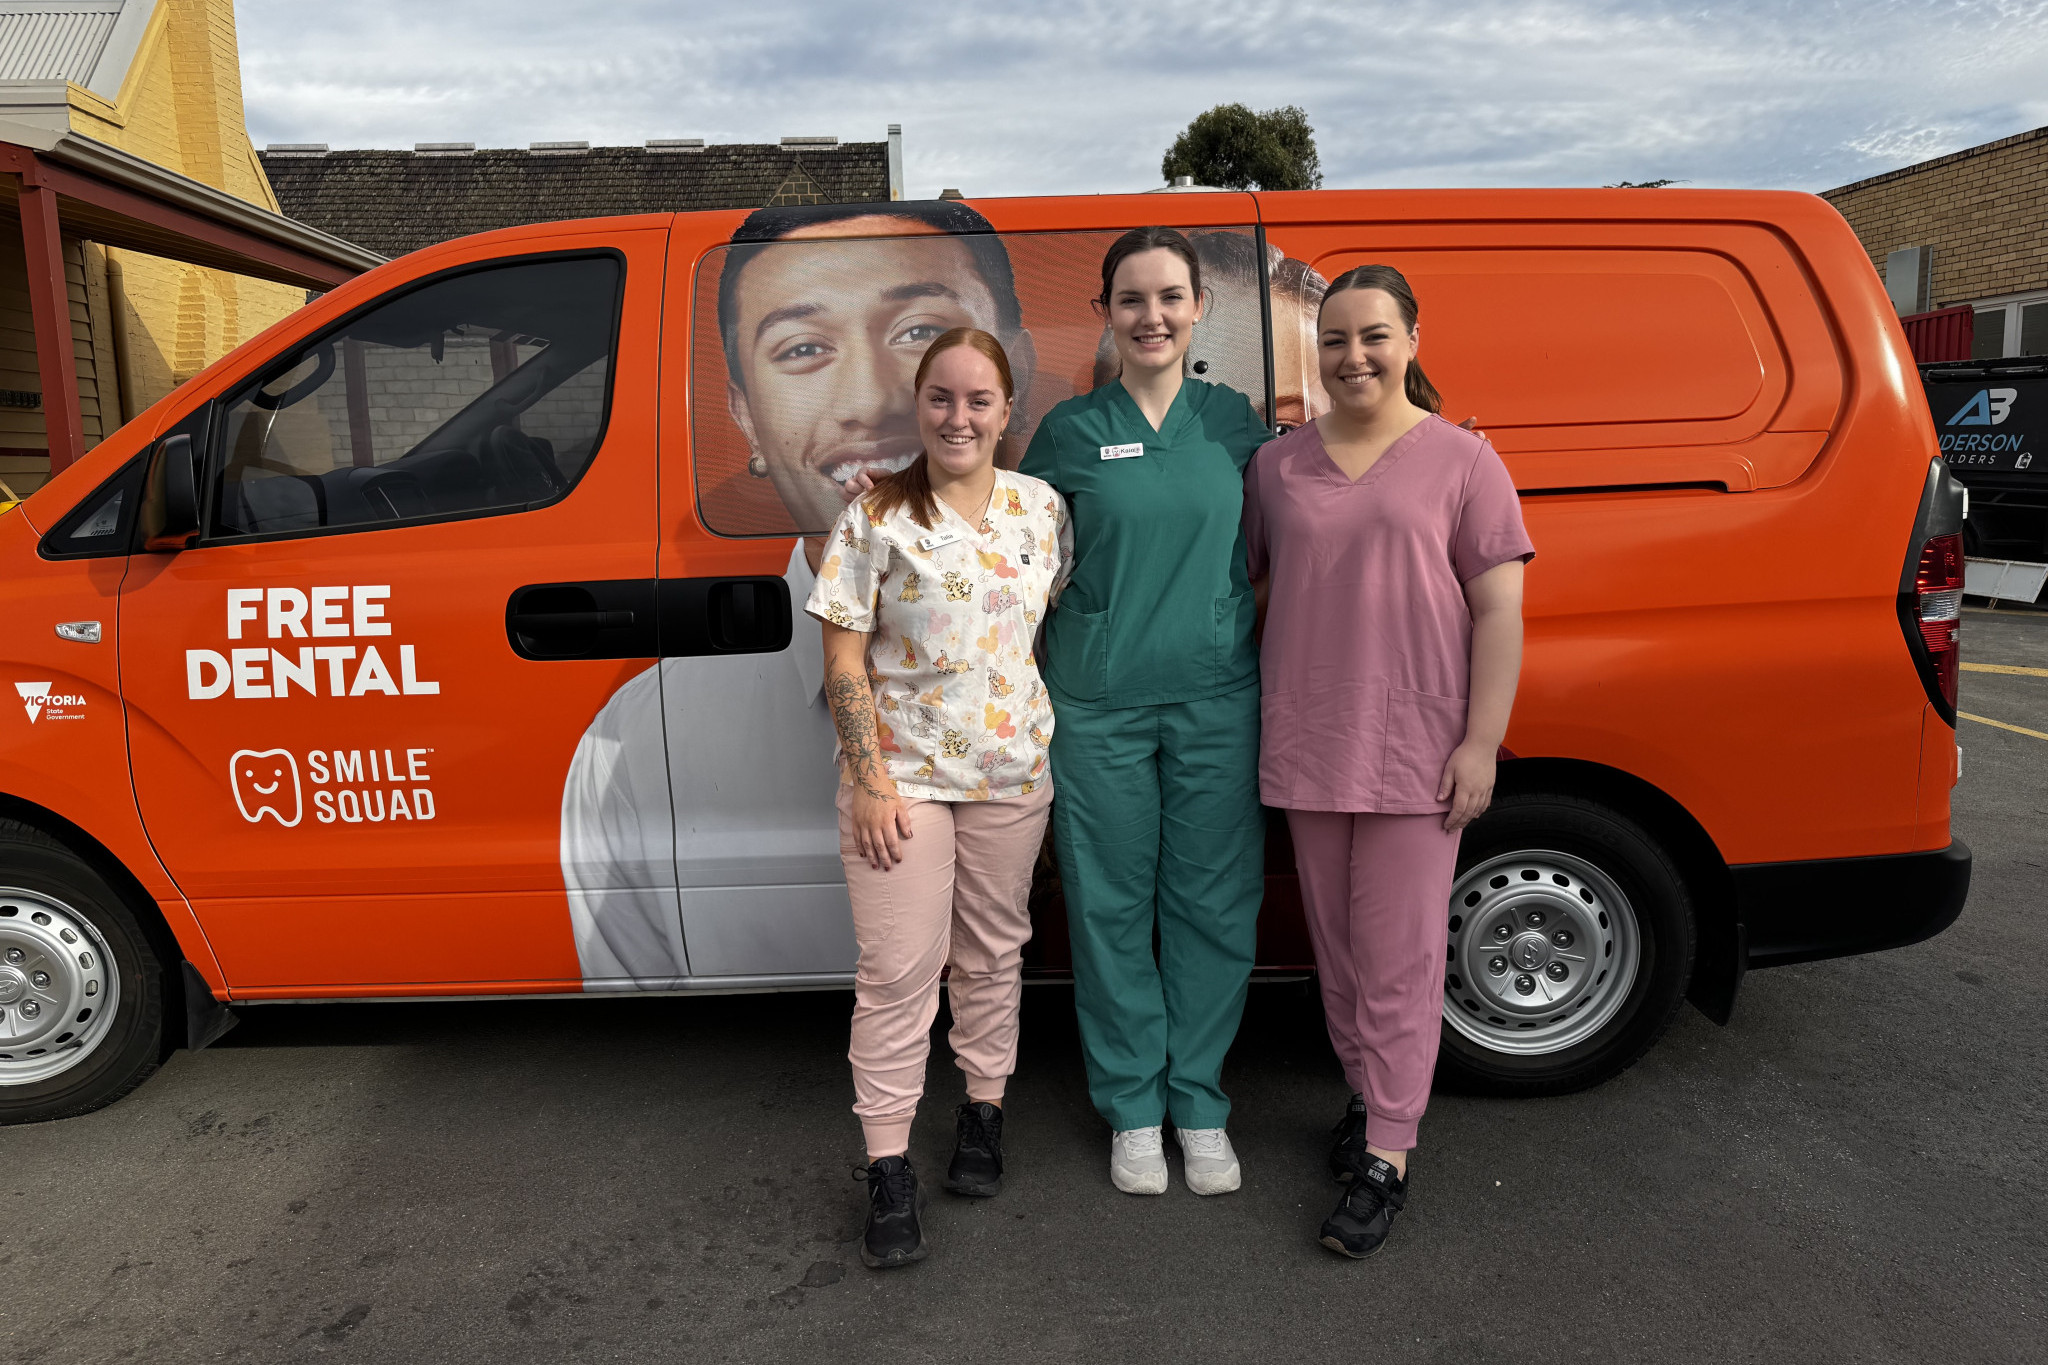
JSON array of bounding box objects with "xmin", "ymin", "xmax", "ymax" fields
[{"xmin": 207, "ymin": 256, "xmax": 623, "ymax": 538}]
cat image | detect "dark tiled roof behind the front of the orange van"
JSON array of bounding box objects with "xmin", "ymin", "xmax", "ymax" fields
[{"xmin": 262, "ymin": 141, "xmax": 889, "ymax": 256}]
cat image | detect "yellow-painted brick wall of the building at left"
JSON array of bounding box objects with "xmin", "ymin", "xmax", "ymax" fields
[{"xmin": 0, "ymin": 0, "xmax": 305, "ymax": 499}]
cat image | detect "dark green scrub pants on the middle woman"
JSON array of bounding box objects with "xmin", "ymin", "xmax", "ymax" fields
[{"xmin": 1053, "ymin": 684, "xmax": 1266, "ymax": 1130}]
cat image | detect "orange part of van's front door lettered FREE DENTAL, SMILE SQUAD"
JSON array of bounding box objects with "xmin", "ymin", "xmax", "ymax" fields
[{"xmin": 110, "ymin": 223, "xmax": 668, "ymax": 993}]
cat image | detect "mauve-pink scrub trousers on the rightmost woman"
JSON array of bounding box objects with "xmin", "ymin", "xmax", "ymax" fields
[{"xmin": 1286, "ymin": 810, "xmax": 1460, "ymax": 1152}]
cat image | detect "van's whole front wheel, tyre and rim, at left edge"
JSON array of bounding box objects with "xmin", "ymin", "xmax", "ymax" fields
[{"xmin": 0, "ymin": 821, "xmax": 164, "ymax": 1124}]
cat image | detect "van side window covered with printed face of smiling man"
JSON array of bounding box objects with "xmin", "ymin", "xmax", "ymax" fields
[{"xmin": 690, "ymin": 225, "xmax": 1269, "ymax": 536}]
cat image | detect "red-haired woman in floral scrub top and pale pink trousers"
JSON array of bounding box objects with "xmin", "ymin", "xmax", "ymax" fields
[{"xmin": 805, "ymin": 327, "xmax": 1069, "ymax": 1269}]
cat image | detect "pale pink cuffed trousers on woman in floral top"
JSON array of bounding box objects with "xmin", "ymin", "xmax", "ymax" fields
[{"xmin": 840, "ymin": 784, "xmax": 1053, "ymax": 1160}]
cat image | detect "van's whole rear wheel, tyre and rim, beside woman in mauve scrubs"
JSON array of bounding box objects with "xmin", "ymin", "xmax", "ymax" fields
[{"xmin": 1438, "ymin": 794, "xmax": 1694, "ymax": 1095}]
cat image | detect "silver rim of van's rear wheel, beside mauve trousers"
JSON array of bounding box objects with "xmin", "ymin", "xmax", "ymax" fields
[{"xmin": 1444, "ymin": 849, "xmax": 1642, "ymax": 1056}]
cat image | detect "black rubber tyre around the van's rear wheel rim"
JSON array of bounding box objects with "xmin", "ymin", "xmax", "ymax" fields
[{"xmin": 1436, "ymin": 792, "xmax": 1696, "ymax": 1095}]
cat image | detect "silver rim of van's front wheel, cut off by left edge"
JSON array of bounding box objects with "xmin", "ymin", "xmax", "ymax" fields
[{"xmin": 0, "ymin": 886, "xmax": 121, "ymax": 1085}]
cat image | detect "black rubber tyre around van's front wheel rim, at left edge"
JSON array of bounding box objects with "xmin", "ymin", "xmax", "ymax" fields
[{"xmin": 0, "ymin": 819, "xmax": 166, "ymax": 1124}]
